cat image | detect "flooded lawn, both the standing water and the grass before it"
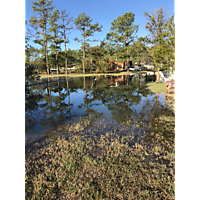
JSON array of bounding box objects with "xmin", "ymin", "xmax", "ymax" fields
[{"xmin": 25, "ymin": 75, "xmax": 175, "ymax": 199}]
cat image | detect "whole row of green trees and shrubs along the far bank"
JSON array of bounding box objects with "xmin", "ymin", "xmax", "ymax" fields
[{"xmin": 25, "ymin": 0, "xmax": 175, "ymax": 82}]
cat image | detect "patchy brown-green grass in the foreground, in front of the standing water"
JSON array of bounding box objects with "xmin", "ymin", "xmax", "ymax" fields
[{"xmin": 25, "ymin": 128, "xmax": 175, "ymax": 199}]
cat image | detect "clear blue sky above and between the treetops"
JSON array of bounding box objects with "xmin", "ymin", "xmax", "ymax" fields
[{"xmin": 25, "ymin": 0, "xmax": 175, "ymax": 50}]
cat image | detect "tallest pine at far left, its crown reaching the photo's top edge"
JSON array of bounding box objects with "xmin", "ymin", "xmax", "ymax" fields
[{"xmin": 29, "ymin": 0, "xmax": 54, "ymax": 74}]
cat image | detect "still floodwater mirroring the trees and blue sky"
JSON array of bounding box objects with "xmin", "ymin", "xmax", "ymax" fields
[{"xmin": 25, "ymin": 74, "xmax": 174, "ymax": 150}]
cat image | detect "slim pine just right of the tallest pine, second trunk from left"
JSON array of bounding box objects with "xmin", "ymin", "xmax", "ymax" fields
[{"xmin": 49, "ymin": 9, "xmax": 63, "ymax": 74}]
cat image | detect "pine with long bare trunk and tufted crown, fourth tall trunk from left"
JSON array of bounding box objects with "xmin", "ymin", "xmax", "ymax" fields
[{"xmin": 74, "ymin": 12, "xmax": 103, "ymax": 74}]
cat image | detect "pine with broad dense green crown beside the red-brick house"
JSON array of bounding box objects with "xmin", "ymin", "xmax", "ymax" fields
[{"xmin": 106, "ymin": 12, "xmax": 139, "ymax": 72}]
